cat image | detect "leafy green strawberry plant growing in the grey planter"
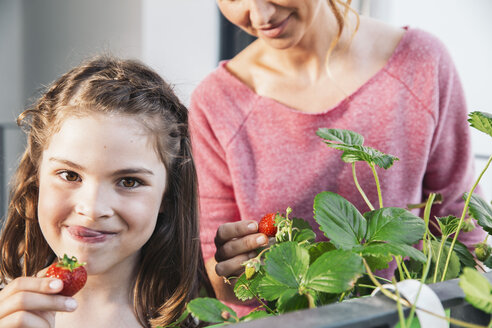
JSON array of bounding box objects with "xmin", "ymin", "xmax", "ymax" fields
[{"xmin": 165, "ymin": 112, "xmax": 492, "ymax": 327}]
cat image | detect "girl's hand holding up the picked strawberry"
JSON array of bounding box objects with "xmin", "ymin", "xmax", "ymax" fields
[{"xmin": 0, "ymin": 277, "xmax": 77, "ymax": 328}]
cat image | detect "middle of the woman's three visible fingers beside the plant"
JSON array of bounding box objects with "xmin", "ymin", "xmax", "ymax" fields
[{"xmin": 215, "ymin": 233, "xmax": 268, "ymax": 262}]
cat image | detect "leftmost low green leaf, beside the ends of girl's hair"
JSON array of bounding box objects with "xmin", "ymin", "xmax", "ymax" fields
[{"xmin": 186, "ymin": 297, "xmax": 237, "ymax": 323}]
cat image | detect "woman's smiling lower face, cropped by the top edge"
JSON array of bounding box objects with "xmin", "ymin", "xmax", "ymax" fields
[{"xmin": 217, "ymin": 0, "xmax": 327, "ymax": 49}]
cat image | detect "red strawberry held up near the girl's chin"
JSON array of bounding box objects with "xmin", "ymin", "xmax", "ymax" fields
[{"xmin": 46, "ymin": 254, "xmax": 87, "ymax": 296}]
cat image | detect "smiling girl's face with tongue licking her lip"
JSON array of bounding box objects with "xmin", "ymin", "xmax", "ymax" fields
[{"xmin": 38, "ymin": 114, "xmax": 166, "ymax": 274}]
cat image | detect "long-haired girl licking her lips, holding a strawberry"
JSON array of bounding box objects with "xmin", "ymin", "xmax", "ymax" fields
[{"xmin": 0, "ymin": 58, "xmax": 209, "ymax": 327}]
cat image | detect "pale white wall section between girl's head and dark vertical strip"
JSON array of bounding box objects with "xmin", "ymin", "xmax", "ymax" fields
[{"xmin": 142, "ymin": 0, "xmax": 219, "ymax": 105}]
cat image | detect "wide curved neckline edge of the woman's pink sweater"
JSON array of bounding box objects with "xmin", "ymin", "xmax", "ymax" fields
[{"xmin": 219, "ymin": 26, "xmax": 414, "ymax": 116}]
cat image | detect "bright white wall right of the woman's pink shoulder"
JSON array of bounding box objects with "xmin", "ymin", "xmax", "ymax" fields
[{"xmin": 363, "ymin": 0, "xmax": 492, "ymax": 201}]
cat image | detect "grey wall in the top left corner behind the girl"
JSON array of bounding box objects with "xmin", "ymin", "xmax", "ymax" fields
[{"xmin": 0, "ymin": 0, "xmax": 142, "ymax": 218}]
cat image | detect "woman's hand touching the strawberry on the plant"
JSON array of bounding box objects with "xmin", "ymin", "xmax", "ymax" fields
[{"xmin": 215, "ymin": 221, "xmax": 268, "ymax": 277}]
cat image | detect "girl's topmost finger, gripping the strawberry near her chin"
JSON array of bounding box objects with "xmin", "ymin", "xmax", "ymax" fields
[{"xmin": 0, "ymin": 277, "xmax": 63, "ymax": 299}]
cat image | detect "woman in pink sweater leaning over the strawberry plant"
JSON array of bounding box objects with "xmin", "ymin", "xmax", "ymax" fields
[{"xmin": 190, "ymin": 0, "xmax": 485, "ymax": 313}]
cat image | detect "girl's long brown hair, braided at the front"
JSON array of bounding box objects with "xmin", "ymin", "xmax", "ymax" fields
[{"xmin": 0, "ymin": 56, "xmax": 207, "ymax": 327}]
